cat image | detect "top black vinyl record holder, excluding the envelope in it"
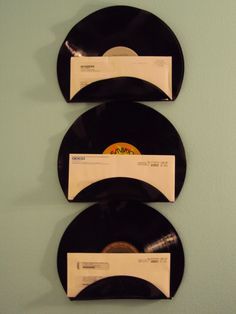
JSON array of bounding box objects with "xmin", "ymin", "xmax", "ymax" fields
[{"xmin": 57, "ymin": 6, "xmax": 184, "ymax": 102}]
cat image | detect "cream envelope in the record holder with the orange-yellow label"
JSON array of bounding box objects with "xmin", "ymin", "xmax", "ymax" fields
[{"xmin": 68, "ymin": 154, "xmax": 175, "ymax": 202}]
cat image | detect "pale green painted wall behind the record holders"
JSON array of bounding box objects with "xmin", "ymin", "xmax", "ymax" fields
[{"xmin": 0, "ymin": 0, "xmax": 236, "ymax": 314}]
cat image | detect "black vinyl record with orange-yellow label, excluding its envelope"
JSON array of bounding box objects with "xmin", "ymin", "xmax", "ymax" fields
[{"xmin": 58, "ymin": 102, "xmax": 186, "ymax": 202}]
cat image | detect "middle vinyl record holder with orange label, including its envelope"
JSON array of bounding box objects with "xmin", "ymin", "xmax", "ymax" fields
[{"xmin": 58, "ymin": 102, "xmax": 186, "ymax": 202}]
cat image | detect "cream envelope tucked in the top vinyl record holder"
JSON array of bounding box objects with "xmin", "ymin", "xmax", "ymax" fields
[{"xmin": 70, "ymin": 56, "xmax": 172, "ymax": 99}]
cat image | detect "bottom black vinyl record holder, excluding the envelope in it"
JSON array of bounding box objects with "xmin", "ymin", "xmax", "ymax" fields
[{"xmin": 57, "ymin": 201, "xmax": 184, "ymax": 299}]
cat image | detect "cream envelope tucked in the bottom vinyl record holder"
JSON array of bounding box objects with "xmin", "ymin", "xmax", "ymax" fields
[{"xmin": 67, "ymin": 253, "xmax": 171, "ymax": 298}]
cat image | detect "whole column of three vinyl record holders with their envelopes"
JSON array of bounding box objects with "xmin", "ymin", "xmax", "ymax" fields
[{"xmin": 57, "ymin": 6, "xmax": 186, "ymax": 300}]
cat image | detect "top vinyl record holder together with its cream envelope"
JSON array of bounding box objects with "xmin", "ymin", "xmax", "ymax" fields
[{"xmin": 57, "ymin": 6, "xmax": 184, "ymax": 102}]
